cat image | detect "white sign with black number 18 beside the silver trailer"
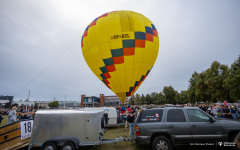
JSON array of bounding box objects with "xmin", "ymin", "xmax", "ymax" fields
[{"xmin": 20, "ymin": 120, "xmax": 33, "ymax": 140}]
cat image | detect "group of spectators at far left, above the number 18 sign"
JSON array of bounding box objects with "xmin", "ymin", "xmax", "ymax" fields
[{"xmin": 0, "ymin": 106, "xmax": 36, "ymax": 124}]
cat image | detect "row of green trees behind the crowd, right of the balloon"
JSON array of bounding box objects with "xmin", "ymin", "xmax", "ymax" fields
[{"xmin": 129, "ymin": 55, "xmax": 240, "ymax": 105}]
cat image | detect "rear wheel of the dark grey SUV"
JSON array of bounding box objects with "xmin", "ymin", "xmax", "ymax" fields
[{"xmin": 152, "ymin": 136, "xmax": 172, "ymax": 150}]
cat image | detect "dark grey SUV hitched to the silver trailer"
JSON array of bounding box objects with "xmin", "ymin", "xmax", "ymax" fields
[{"xmin": 133, "ymin": 107, "xmax": 240, "ymax": 150}]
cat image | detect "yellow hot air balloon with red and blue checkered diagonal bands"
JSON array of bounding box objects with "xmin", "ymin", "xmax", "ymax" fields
[{"xmin": 81, "ymin": 10, "xmax": 159, "ymax": 103}]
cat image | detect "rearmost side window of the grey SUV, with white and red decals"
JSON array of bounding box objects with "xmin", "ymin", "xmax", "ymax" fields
[{"xmin": 137, "ymin": 109, "xmax": 163, "ymax": 123}]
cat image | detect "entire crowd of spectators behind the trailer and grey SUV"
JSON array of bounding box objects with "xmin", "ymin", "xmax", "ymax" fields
[{"xmin": 0, "ymin": 101, "xmax": 240, "ymax": 148}]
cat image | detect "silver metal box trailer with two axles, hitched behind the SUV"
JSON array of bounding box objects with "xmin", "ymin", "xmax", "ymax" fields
[{"xmin": 29, "ymin": 110, "xmax": 123, "ymax": 150}]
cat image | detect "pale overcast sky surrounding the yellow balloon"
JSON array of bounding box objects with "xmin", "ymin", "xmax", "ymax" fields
[{"xmin": 0, "ymin": 0, "xmax": 240, "ymax": 101}]
